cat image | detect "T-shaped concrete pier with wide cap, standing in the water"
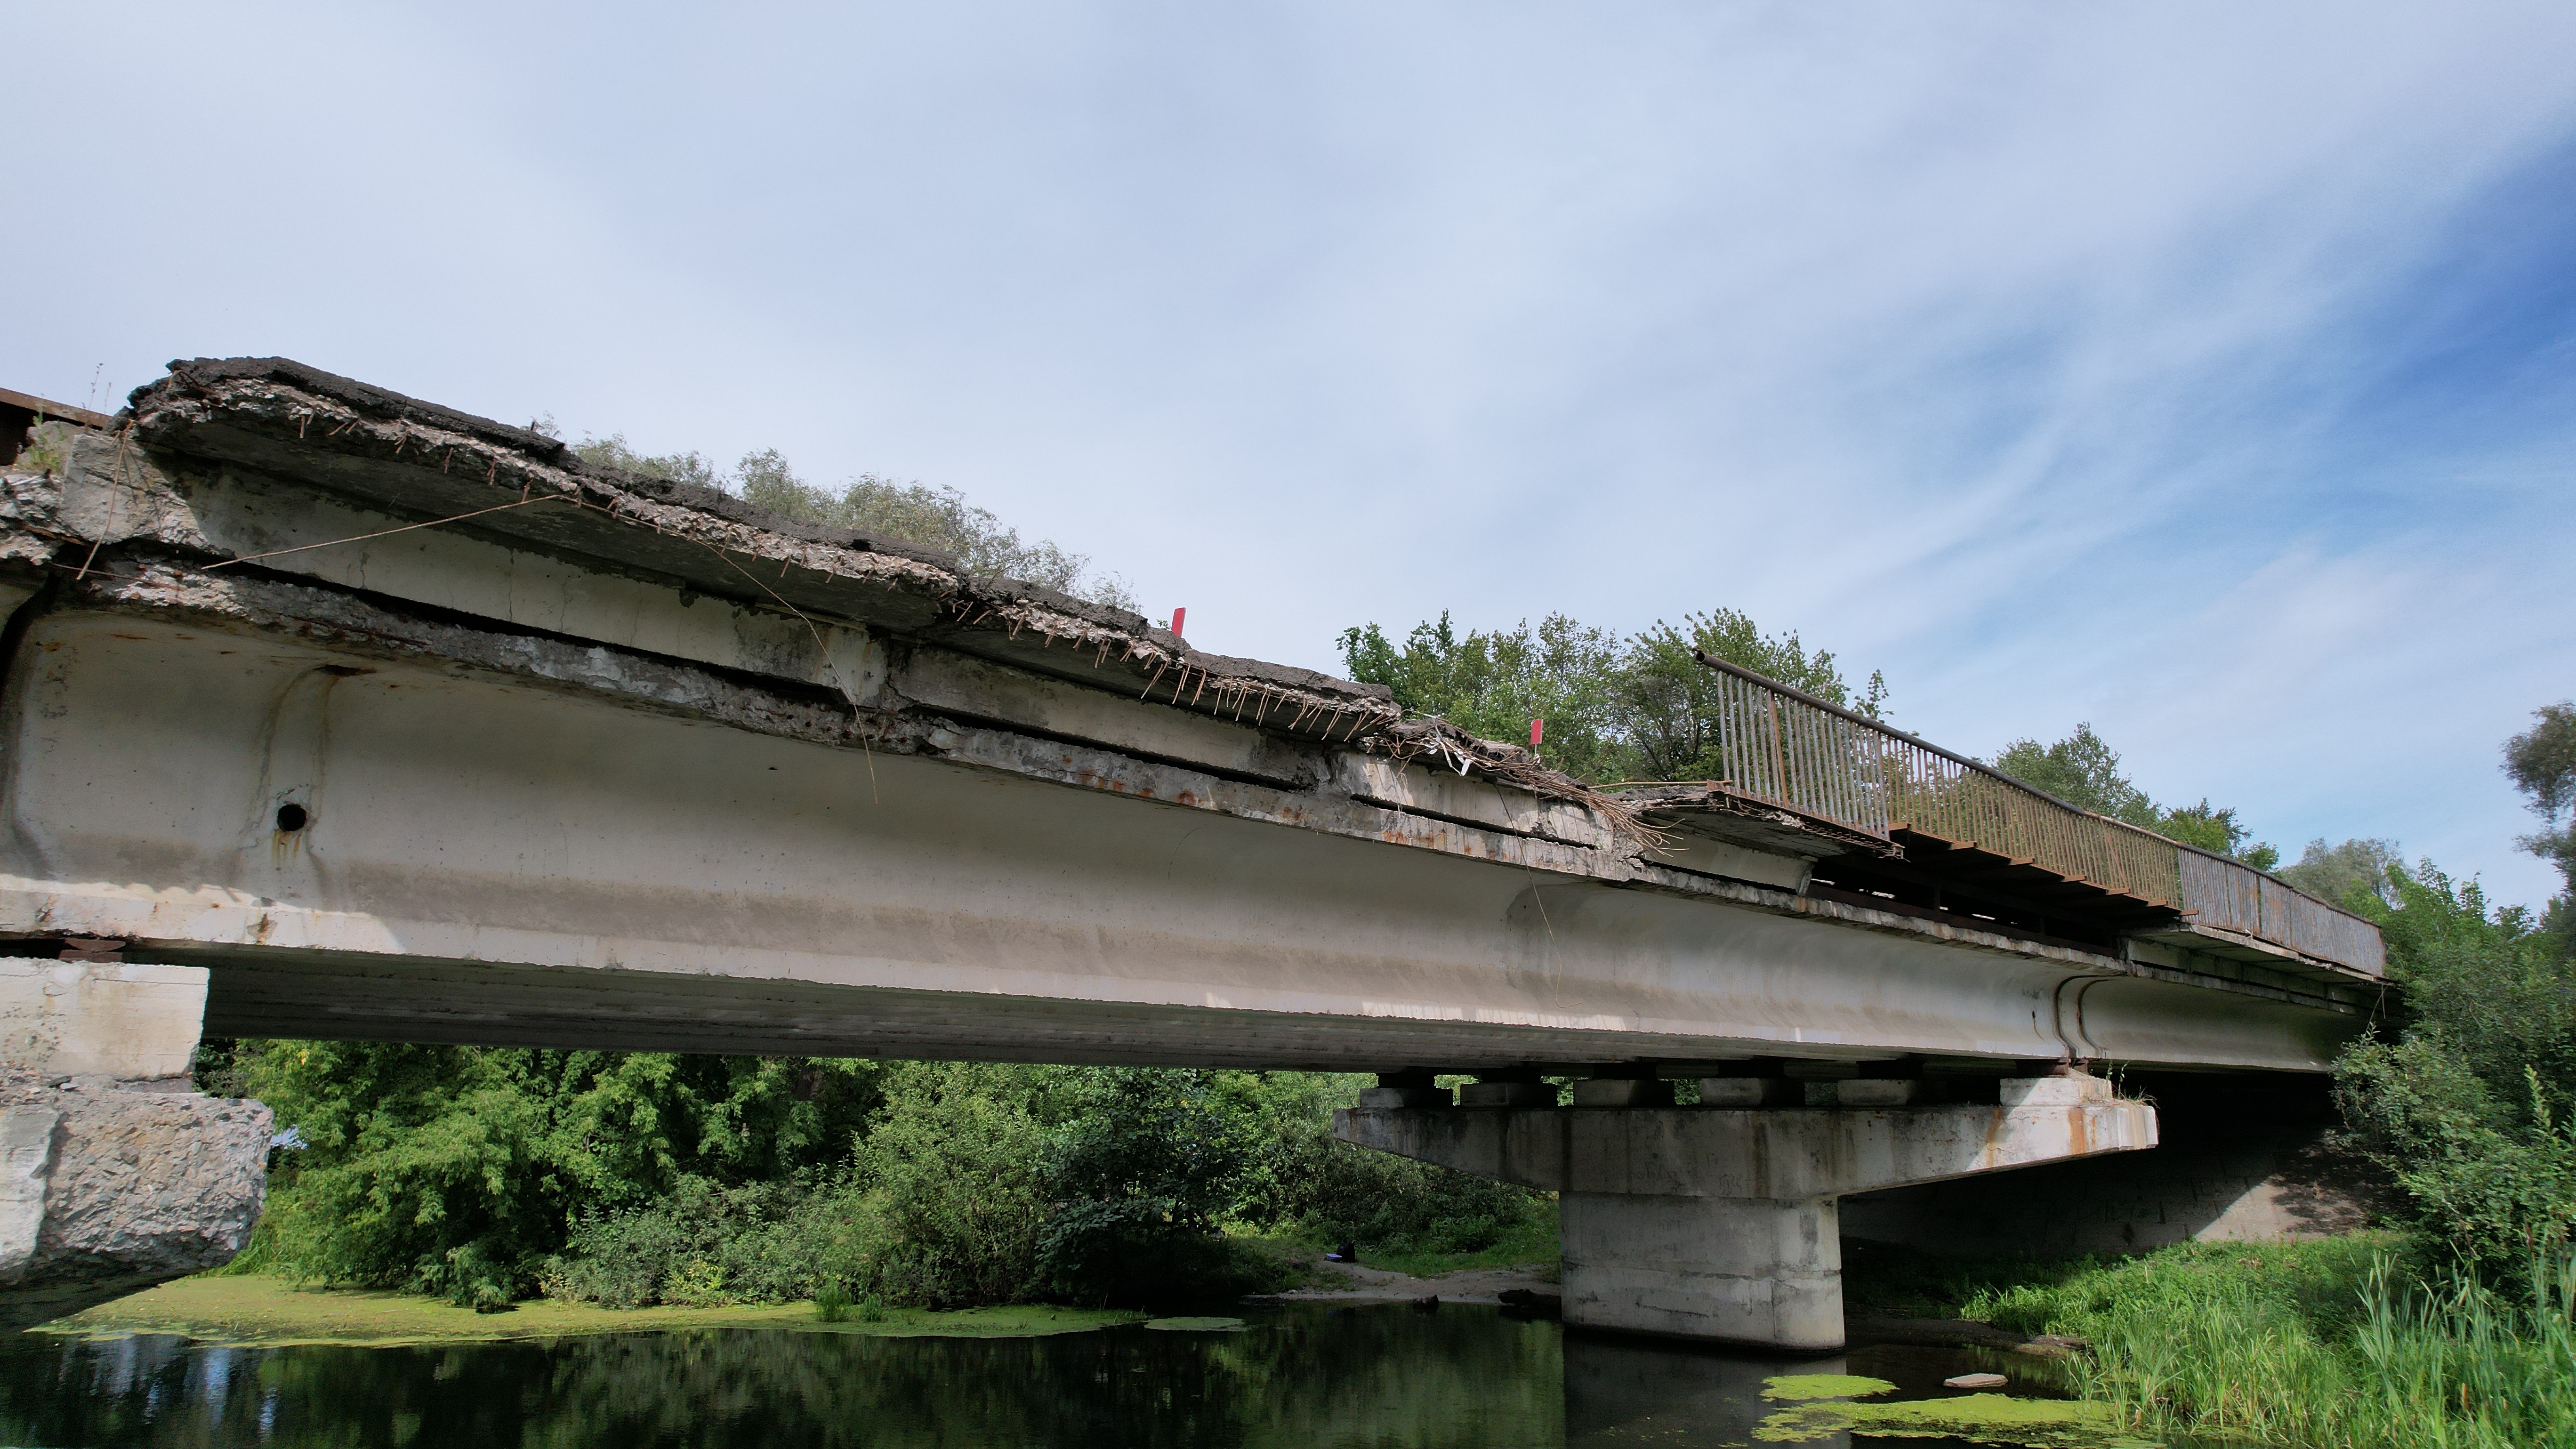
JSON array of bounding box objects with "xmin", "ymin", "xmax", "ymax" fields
[{"xmin": 1334, "ymin": 1072, "xmax": 2156, "ymax": 1353}]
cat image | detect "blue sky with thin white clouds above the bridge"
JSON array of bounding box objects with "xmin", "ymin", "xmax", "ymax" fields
[{"xmin": 20, "ymin": 0, "xmax": 2576, "ymax": 902}]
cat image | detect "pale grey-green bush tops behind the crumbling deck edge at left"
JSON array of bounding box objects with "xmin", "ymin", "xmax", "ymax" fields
[{"xmin": 572, "ymin": 433, "xmax": 1136, "ymax": 611}]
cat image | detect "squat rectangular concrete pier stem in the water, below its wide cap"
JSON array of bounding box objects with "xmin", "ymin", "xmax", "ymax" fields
[{"xmin": 1559, "ymin": 1191, "xmax": 1842, "ymax": 1351}]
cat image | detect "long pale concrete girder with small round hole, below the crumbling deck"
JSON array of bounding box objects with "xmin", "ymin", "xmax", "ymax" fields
[{"xmin": 0, "ymin": 603, "xmax": 2347, "ymax": 1070}]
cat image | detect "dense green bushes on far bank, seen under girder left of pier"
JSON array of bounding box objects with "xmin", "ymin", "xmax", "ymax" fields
[{"xmin": 261, "ymin": 1042, "xmax": 1530, "ymax": 1320}]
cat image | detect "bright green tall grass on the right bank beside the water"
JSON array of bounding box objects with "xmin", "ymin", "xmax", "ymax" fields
[{"xmin": 1968, "ymin": 1238, "xmax": 2576, "ymax": 1449}]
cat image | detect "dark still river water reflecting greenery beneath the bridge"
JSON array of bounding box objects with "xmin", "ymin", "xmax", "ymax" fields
[{"xmin": 0, "ymin": 1304, "xmax": 2048, "ymax": 1449}]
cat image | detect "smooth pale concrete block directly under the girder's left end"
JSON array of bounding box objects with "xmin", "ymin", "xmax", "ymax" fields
[{"xmin": 0, "ymin": 957, "xmax": 206, "ymax": 1080}]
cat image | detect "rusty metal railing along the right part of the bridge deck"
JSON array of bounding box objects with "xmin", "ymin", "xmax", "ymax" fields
[{"xmin": 1692, "ymin": 650, "xmax": 2383, "ymax": 974}]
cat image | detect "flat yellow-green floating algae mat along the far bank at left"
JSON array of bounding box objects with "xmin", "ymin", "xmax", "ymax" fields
[{"xmin": 39, "ymin": 1274, "xmax": 1146, "ymax": 1348}]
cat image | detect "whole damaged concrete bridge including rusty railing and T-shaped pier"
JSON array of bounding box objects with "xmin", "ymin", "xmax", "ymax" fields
[{"xmin": 0, "ymin": 358, "xmax": 2380, "ymax": 1348}]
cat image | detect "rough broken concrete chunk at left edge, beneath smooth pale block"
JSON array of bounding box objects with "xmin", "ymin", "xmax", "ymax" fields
[{"xmin": 0, "ymin": 1072, "xmax": 271, "ymax": 1330}]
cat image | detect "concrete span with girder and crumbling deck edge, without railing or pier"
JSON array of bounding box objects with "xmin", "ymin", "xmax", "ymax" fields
[{"xmin": 0, "ymin": 358, "xmax": 2365, "ymax": 1070}]
